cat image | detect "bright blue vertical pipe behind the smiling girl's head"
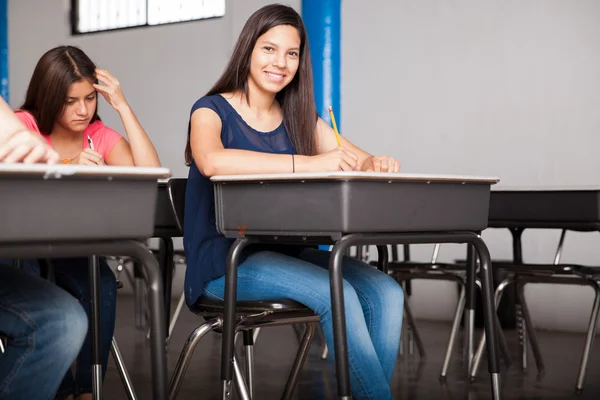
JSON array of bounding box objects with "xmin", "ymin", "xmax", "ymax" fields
[{"xmin": 302, "ymin": 0, "xmax": 342, "ymax": 133}]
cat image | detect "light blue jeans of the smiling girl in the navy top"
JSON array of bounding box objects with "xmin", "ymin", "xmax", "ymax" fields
[{"xmin": 204, "ymin": 249, "xmax": 404, "ymax": 400}]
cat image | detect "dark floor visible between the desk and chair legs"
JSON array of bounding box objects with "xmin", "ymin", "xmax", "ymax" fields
[{"xmin": 104, "ymin": 295, "xmax": 600, "ymax": 400}]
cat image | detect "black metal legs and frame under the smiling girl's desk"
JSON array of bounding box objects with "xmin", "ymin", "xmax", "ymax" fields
[{"xmin": 221, "ymin": 232, "xmax": 500, "ymax": 400}]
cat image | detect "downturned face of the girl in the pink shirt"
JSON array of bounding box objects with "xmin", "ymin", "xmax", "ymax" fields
[{"xmin": 56, "ymin": 78, "xmax": 96, "ymax": 133}]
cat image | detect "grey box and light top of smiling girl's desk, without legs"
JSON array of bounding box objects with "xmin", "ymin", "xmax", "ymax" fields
[{"xmin": 212, "ymin": 172, "xmax": 498, "ymax": 238}]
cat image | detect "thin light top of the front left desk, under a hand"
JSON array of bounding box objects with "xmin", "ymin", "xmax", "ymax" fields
[{"xmin": 0, "ymin": 164, "xmax": 171, "ymax": 180}]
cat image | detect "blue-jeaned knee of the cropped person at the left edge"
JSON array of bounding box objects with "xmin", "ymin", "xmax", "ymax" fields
[{"xmin": 0, "ymin": 265, "xmax": 88, "ymax": 400}]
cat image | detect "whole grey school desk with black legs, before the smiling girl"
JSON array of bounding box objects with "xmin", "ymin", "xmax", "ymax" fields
[{"xmin": 211, "ymin": 172, "xmax": 500, "ymax": 399}]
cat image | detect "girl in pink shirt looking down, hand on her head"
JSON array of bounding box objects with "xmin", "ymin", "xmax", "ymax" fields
[{"xmin": 11, "ymin": 46, "xmax": 160, "ymax": 400}]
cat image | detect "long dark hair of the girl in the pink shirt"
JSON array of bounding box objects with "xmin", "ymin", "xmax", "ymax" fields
[{"xmin": 20, "ymin": 46, "xmax": 100, "ymax": 134}]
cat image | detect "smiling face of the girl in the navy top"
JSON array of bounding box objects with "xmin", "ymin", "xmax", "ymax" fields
[{"xmin": 249, "ymin": 25, "xmax": 300, "ymax": 94}]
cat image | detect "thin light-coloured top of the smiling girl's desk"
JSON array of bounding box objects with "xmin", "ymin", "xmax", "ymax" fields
[{"xmin": 211, "ymin": 171, "xmax": 500, "ymax": 184}]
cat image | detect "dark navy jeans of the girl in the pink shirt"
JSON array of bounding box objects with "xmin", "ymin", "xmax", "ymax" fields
[{"xmin": 3, "ymin": 257, "xmax": 117, "ymax": 396}]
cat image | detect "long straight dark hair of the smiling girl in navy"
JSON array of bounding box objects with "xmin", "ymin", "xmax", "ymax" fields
[{"xmin": 185, "ymin": 4, "xmax": 317, "ymax": 165}]
